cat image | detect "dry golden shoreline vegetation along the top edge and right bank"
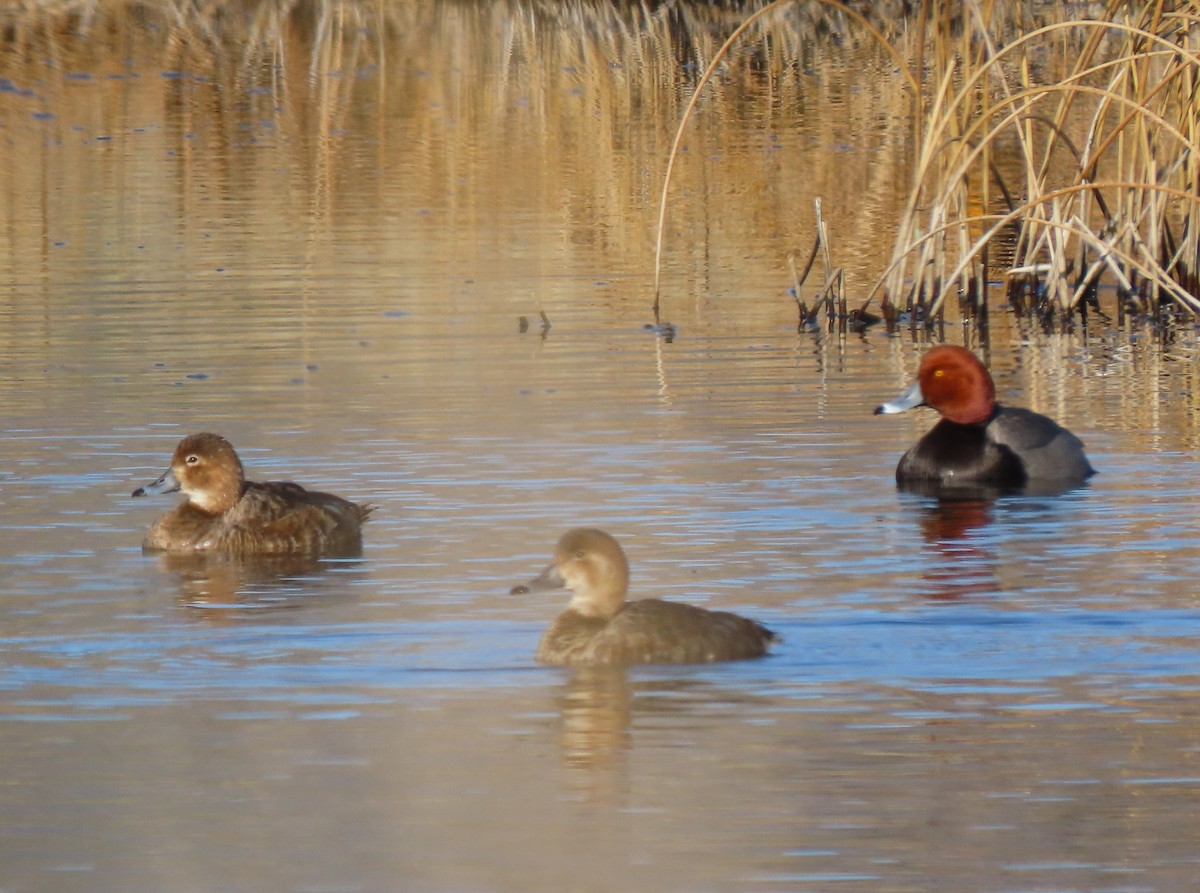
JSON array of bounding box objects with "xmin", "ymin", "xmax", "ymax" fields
[{"xmin": 9, "ymin": 0, "xmax": 1200, "ymax": 332}]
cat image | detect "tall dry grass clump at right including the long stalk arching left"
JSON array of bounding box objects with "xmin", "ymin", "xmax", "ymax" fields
[{"xmin": 654, "ymin": 0, "xmax": 1200, "ymax": 325}]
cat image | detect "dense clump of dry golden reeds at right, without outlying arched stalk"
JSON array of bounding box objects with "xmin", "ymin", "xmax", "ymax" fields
[{"xmin": 888, "ymin": 4, "xmax": 1200, "ymax": 318}]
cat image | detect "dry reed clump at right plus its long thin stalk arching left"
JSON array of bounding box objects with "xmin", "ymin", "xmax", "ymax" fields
[{"xmin": 653, "ymin": 0, "xmax": 1200, "ymax": 320}]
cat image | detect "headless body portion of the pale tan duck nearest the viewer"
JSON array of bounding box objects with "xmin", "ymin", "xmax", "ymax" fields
[{"xmin": 538, "ymin": 599, "xmax": 776, "ymax": 665}]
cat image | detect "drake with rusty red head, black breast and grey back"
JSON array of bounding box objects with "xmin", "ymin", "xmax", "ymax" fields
[{"xmin": 875, "ymin": 344, "xmax": 1096, "ymax": 492}]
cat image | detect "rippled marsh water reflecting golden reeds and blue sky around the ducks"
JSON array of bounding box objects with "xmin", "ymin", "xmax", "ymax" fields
[{"xmin": 0, "ymin": 4, "xmax": 1200, "ymax": 893}]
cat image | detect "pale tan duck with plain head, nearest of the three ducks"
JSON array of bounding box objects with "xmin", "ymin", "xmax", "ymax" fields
[{"xmin": 512, "ymin": 527, "xmax": 778, "ymax": 666}]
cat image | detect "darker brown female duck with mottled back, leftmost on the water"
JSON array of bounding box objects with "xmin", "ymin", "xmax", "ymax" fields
[{"xmin": 133, "ymin": 433, "xmax": 374, "ymax": 556}]
